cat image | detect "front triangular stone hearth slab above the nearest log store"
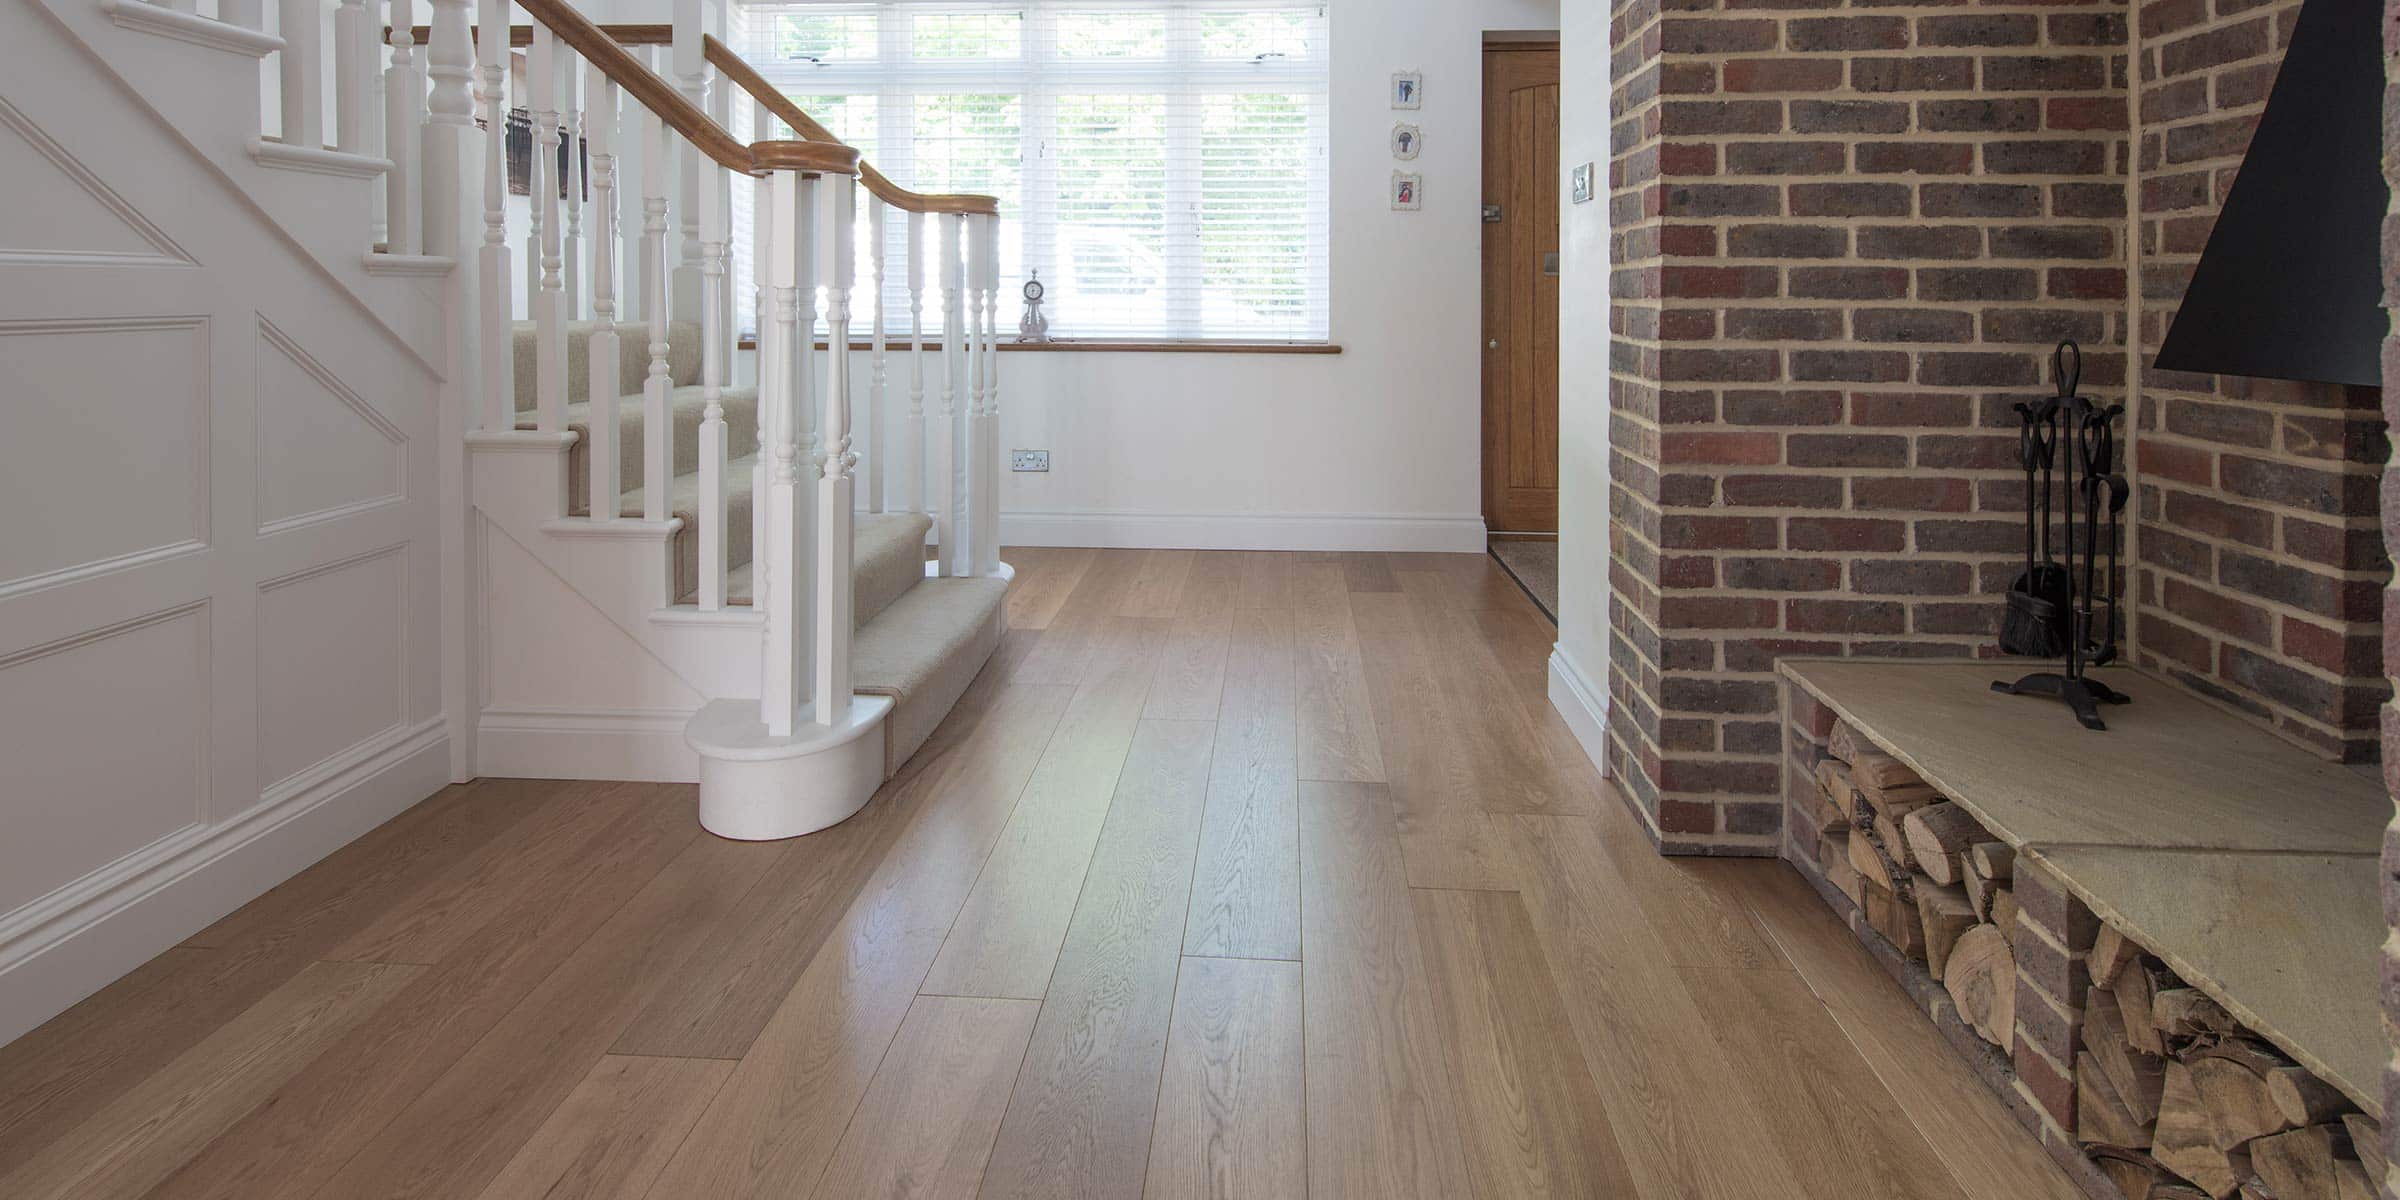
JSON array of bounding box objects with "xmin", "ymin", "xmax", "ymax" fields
[{"xmin": 2030, "ymin": 847, "xmax": 2388, "ymax": 1116}]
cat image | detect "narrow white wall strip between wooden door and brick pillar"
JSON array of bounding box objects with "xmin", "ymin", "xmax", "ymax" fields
[{"xmin": 1558, "ymin": 0, "xmax": 1608, "ymax": 701}]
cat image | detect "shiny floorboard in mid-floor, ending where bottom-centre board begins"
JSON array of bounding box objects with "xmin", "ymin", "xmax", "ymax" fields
[{"xmin": 1183, "ymin": 607, "xmax": 1301, "ymax": 958}]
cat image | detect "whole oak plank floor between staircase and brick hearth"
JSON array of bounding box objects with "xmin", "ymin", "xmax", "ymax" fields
[{"xmin": 0, "ymin": 550, "xmax": 2076, "ymax": 1200}]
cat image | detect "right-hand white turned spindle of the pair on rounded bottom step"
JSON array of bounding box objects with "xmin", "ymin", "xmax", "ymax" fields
[{"xmin": 814, "ymin": 175, "xmax": 859, "ymax": 727}]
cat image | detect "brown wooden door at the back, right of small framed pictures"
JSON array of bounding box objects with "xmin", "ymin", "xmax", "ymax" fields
[{"xmin": 1483, "ymin": 43, "xmax": 1558, "ymax": 533}]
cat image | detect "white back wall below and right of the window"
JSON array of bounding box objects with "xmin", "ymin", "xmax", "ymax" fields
[{"xmin": 979, "ymin": 0, "xmax": 1558, "ymax": 552}]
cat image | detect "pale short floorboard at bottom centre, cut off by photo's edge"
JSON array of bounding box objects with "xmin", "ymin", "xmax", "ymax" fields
[{"xmin": 1126, "ymin": 958, "xmax": 1308, "ymax": 1200}]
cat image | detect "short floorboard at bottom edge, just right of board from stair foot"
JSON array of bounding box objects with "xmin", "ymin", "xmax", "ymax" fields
[{"xmin": 811, "ymin": 996, "xmax": 1042, "ymax": 1200}]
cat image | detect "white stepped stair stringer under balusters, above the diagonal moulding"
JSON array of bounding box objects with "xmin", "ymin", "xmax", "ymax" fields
[{"xmin": 468, "ymin": 432, "xmax": 766, "ymax": 701}]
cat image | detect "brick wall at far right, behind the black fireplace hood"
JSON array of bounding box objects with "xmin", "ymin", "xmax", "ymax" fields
[{"xmin": 2136, "ymin": 0, "xmax": 2390, "ymax": 761}]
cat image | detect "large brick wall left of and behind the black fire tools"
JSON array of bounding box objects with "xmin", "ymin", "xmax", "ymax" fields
[{"xmin": 1610, "ymin": 0, "xmax": 2129, "ymax": 852}]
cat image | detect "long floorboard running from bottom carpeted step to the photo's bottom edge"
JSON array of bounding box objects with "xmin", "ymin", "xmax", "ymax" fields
[{"xmin": 650, "ymin": 686, "xmax": 1070, "ymax": 1200}]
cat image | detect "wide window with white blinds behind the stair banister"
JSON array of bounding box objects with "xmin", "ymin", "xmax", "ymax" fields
[{"xmin": 732, "ymin": 0, "xmax": 1330, "ymax": 341}]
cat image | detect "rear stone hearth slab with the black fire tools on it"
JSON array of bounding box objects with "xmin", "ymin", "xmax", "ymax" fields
[{"xmin": 1781, "ymin": 660, "xmax": 2393, "ymax": 859}]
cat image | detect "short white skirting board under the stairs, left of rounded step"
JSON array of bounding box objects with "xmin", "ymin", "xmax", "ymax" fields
[{"xmin": 475, "ymin": 708, "xmax": 701, "ymax": 782}]
